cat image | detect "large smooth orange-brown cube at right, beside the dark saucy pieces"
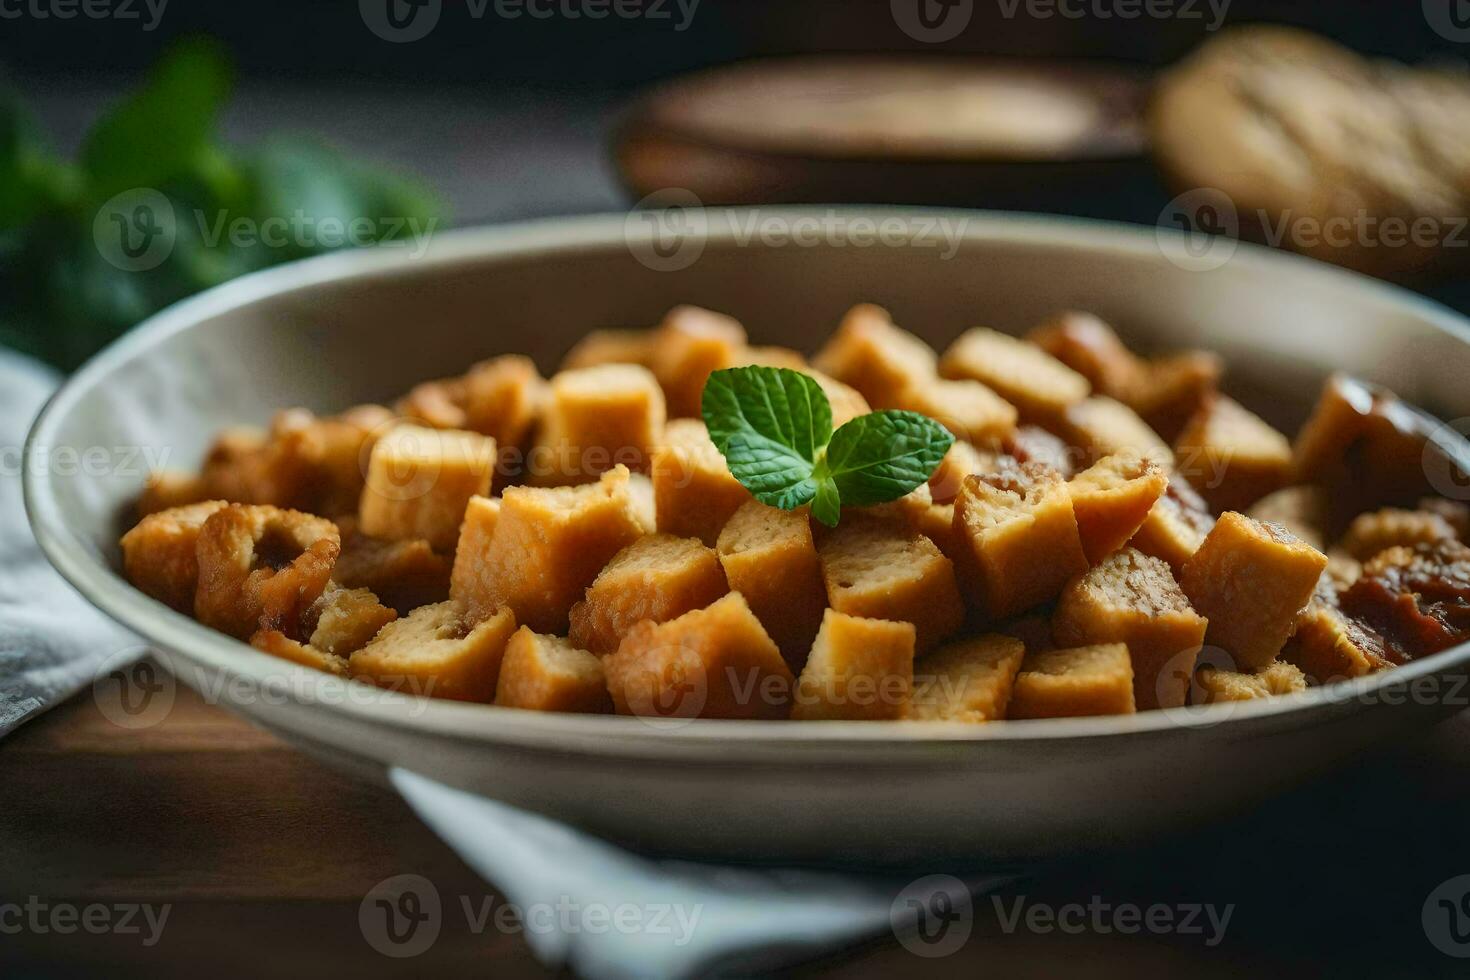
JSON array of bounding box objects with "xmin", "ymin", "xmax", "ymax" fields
[{"xmin": 1179, "ymin": 511, "xmax": 1327, "ymax": 670}]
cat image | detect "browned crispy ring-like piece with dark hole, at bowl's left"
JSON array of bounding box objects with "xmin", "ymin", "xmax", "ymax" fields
[{"xmin": 194, "ymin": 504, "xmax": 343, "ymax": 639}]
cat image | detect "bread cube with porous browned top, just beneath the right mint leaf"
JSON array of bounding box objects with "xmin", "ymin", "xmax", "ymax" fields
[{"xmin": 817, "ymin": 519, "xmax": 964, "ymax": 649}]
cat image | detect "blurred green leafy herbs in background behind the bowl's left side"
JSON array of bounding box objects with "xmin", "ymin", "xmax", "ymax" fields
[{"xmin": 0, "ymin": 40, "xmax": 440, "ymax": 369}]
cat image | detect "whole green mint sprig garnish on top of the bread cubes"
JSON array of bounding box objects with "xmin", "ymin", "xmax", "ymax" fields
[{"xmin": 701, "ymin": 366, "xmax": 954, "ymax": 527}]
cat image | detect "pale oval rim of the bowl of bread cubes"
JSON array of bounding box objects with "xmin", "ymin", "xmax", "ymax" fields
[{"xmin": 22, "ymin": 204, "xmax": 1470, "ymax": 765}]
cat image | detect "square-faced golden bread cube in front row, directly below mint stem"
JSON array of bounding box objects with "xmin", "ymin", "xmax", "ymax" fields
[{"xmin": 791, "ymin": 610, "xmax": 914, "ymax": 721}]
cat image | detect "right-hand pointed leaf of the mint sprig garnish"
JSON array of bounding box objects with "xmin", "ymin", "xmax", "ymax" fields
[{"xmin": 823, "ymin": 411, "xmax": 954, "ymax": 507}]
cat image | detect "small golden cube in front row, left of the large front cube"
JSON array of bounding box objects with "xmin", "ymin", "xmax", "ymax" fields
[{"xmin": 495, "ymin": 626, "xmax": 613, "ymax": 714}]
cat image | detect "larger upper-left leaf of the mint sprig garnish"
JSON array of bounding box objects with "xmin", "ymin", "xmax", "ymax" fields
[{"xmin": 701, "ymin": 366, "xmax": 832, "ymax": 461}]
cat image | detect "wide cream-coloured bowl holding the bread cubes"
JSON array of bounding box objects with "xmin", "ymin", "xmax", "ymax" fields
[{"xmin": 25, "ymin": 209, "xmax": 1470, "ymax": 865}]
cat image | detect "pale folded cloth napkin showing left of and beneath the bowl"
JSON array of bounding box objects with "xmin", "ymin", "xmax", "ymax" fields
[{"xmin": 0, "ymin": 350, "xmax": 1005, "ymax": 980}]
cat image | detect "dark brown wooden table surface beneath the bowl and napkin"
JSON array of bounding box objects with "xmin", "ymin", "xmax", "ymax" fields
[{"xmin": 0, "ymin": 664, "xmax": 1470, "ymax": 977}]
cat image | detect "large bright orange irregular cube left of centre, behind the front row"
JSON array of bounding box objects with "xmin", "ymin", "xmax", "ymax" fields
[{"xmin": 450, "ymin": 466, "xmax": 642, "ymax": 635}]
